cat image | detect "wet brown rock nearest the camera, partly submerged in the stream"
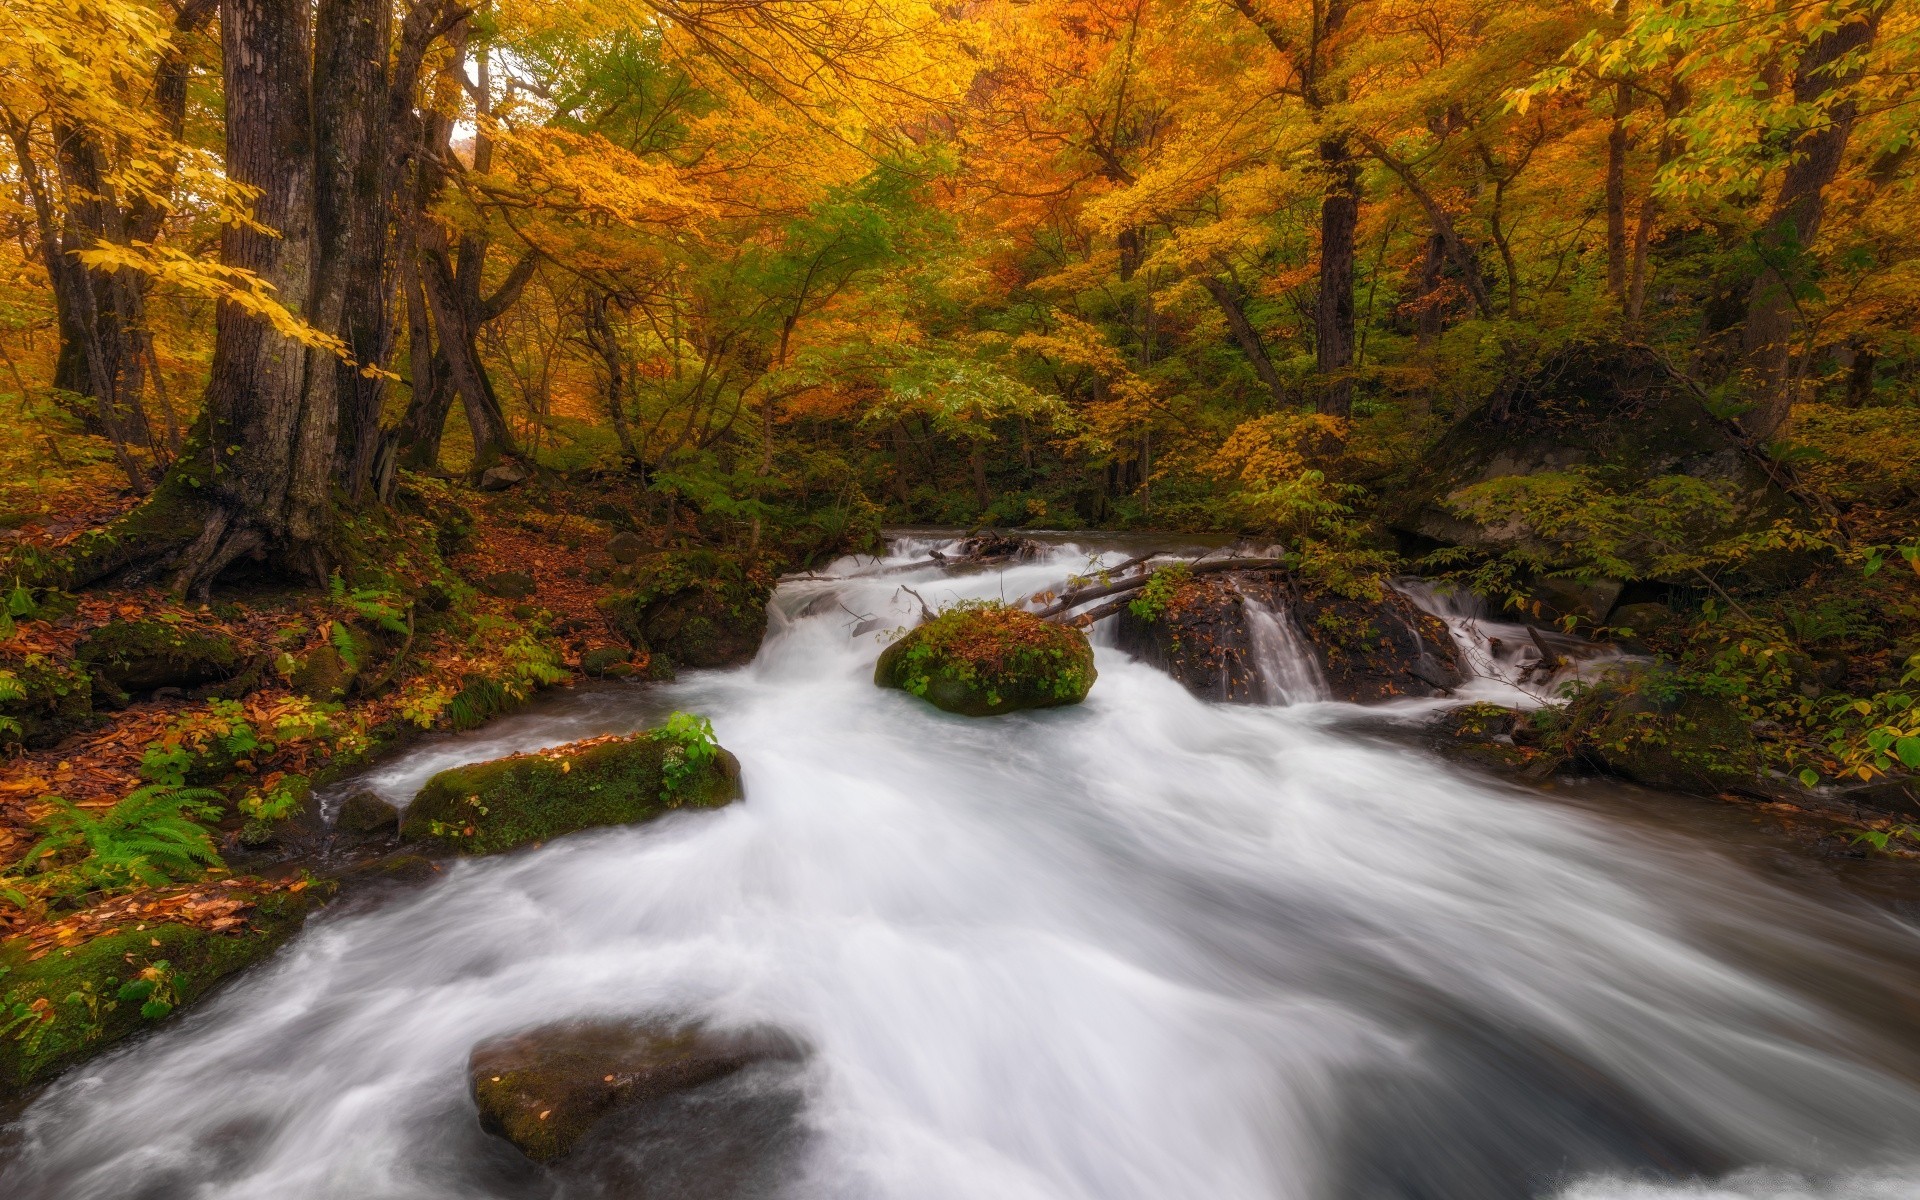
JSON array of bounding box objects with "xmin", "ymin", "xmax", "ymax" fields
[{"xmin": 468, "ymin": 1021, "xmax": 804, "ymax": 1164}]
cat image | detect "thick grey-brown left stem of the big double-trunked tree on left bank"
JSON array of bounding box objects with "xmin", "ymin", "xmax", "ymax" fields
[{"xmin": 173, "ymin": 0, "xmax": 338, "ymax": 595}]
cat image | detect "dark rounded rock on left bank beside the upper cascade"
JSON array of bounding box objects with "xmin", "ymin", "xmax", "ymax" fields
[{"xmin": 601, "ymin": 549, "xmax": 774, "ymax": 666}]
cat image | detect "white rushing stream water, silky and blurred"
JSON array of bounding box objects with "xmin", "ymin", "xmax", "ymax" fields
[{"xmin": 0, "ymin": 545, "xmax": 1920, "ymax": 1200}]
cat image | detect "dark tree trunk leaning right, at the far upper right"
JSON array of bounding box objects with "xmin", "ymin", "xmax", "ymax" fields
[{"xmin": 1740, "ymin": 12, "xmax": 1878, "ymax": 442}]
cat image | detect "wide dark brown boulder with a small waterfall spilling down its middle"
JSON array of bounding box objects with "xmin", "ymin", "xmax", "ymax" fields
[{"xmin": 1116, "ymin": 570, "xmax": 1461, "ymax": 705}]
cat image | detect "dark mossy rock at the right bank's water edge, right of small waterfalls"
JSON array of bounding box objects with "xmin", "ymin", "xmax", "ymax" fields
[{"xmin": 1557, "ymin": 670, "xmax": 1761, "ymax": 791}]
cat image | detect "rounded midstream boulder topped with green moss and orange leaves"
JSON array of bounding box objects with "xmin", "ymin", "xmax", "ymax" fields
[{"xmin": 874, "ymin": 605, "xmax": 1098, "ymax": 716}]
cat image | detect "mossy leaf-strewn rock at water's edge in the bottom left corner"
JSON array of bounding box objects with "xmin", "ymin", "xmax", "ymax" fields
[{"xmin": 0, "ymin": 885, "xmax": 328, "ymax": 1100}]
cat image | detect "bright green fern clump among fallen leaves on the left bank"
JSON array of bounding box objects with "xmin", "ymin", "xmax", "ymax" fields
[{"xmin": 8, "ymin": 783, "xmax": 221, "ymax": 902}]
